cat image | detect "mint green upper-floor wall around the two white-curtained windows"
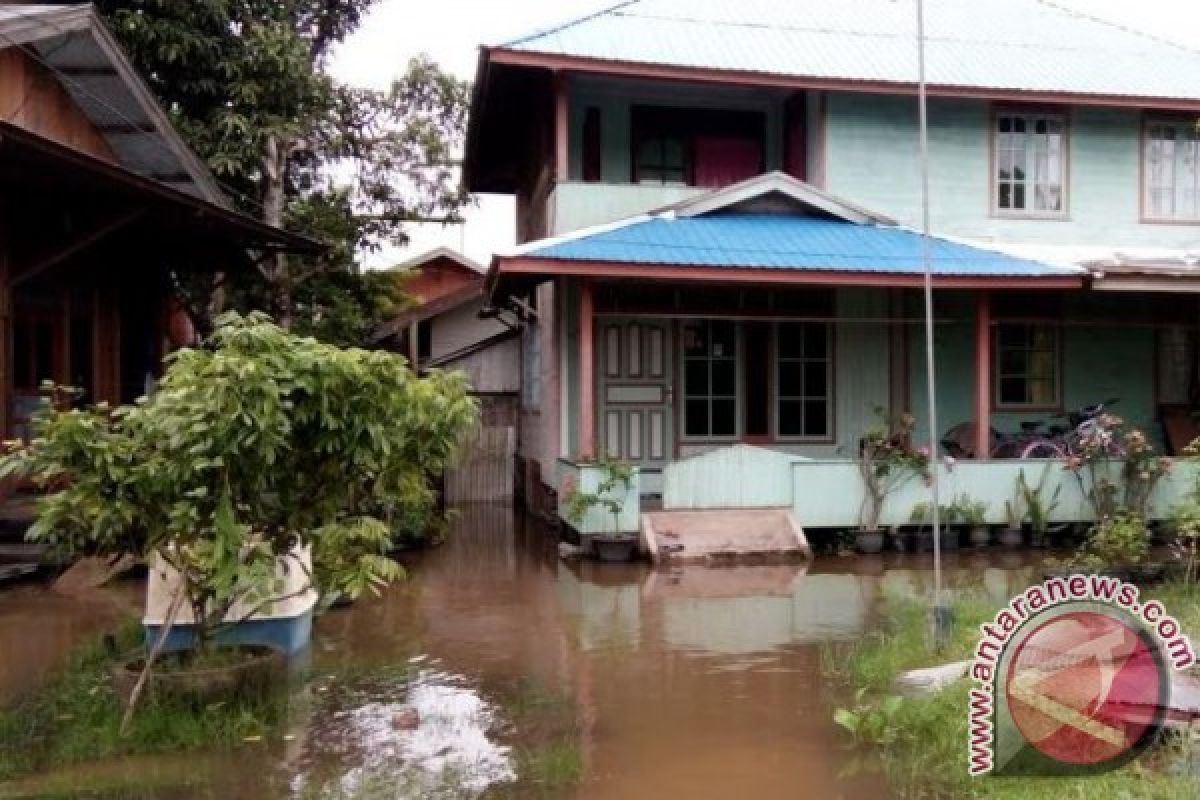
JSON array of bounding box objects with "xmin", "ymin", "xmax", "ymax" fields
[{"xmin": 826, "ymin": 94, "xmax": 1200, "ymax": 246}]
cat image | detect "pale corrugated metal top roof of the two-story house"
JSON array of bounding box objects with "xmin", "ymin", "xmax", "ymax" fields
[{"xmin": 498, "ymin": 0, "xmax": 1200, "ymax": 100}]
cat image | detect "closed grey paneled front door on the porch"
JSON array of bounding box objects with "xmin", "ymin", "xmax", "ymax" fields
[{"xmin": 595, "ymin": 317, "xmax": 674, "ymax": 469}]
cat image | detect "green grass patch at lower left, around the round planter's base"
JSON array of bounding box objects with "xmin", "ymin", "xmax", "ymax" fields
[{"xmin": 0, "ymin": 626, "xmax": 287, "ymax": 781}]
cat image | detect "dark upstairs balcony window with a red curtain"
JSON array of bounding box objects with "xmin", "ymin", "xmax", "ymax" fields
[{"xmin": 631, "ymin": 106, "xmax": 767, "ymax": 188}]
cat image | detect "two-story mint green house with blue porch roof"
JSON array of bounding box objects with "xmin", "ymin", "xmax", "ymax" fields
[{"xmin": 467, "ymin": 0, "xmax": 1200, "ymax": 537}]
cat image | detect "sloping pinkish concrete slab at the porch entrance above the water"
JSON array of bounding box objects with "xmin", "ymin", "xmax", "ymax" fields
[{"xmin": 641, "ymin": 509, "xmax": 812, "ymax": 564}]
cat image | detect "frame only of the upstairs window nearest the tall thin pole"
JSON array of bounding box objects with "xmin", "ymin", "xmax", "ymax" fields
[{"xmin": 988, "ymin": 108, "xmax": 1070, "ymax": 219}]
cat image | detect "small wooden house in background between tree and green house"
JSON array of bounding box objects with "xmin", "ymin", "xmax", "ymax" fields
[{"xmin": 376, "ymin": 247, "xmax": 521, "ymax": 427}]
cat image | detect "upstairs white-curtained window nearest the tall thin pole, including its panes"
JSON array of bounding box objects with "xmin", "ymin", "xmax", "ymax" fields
[{"xmin": 992, "ymin": 110, "xmax": 1067, "ymax": 217}]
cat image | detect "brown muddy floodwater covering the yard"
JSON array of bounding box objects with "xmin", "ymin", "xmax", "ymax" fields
[{"xmin": 0, "ymin": 507, "xmax": 1051, "ymax": 800}]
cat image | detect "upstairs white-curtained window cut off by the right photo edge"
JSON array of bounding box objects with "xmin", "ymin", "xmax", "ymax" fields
[{"xmin": 1142, "ymin": 120, "xmax": 1200, "ymax": 222}]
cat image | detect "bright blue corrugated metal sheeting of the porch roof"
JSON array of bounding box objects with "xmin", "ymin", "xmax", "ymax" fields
[{"xmin": 522, "ymin": 212, "xmax": 1085, "ymax": 277}]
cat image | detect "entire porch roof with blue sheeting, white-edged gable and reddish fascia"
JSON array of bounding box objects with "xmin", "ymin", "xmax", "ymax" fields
[{"xmin": 490, "ymin": 174, "xmax": 1087, "ymax": 293}]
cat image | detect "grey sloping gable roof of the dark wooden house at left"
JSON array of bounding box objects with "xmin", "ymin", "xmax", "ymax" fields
[{"xmin": 0, "ymin": 4, "xmax": 228, "ymax": 206}]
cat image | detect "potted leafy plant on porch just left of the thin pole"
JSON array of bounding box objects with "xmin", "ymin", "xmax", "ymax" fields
[{"xmin": 854, "ymin": 411, "xmax": 929, "ymax": 553}]
